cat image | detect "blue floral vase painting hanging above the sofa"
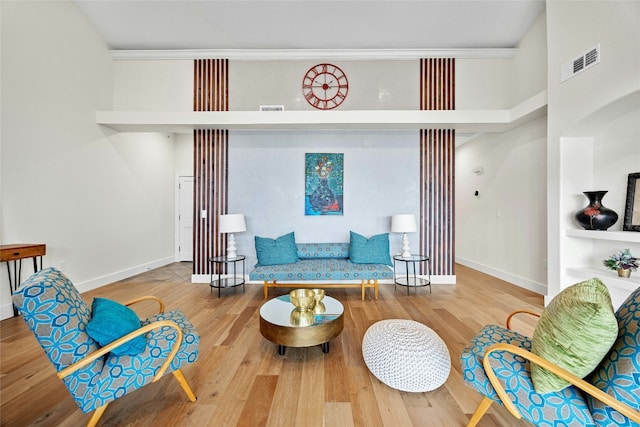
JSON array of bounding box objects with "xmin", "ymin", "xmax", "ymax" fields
[{"xmin": 304, "ymin": 153, "xmax": 344, "ymax": 215}]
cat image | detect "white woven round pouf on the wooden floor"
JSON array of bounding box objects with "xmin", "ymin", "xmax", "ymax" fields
[{"xmin": 362, "ymin": 319, "xmax": 451, "ymax": 392}]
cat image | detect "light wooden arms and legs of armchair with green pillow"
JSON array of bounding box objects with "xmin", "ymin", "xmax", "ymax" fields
[{"xmin": 467, "ymin": 310, "xmax": 640, "ymax": 427}]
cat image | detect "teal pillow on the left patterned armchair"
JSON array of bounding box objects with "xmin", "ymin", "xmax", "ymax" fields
[{"xmin": 86, "ymin": 298, "xmax": 147, "ymax": 356}]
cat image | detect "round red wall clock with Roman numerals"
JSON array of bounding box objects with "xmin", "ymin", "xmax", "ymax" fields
[{"xmin": 302, "ymin": 64, "xmax": 349, "ymax": 110}]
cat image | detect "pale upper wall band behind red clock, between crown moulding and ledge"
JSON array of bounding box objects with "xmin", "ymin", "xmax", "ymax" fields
[{"xmin": 114, "ymin": 56, "xmax": 524, "ymax": 111}]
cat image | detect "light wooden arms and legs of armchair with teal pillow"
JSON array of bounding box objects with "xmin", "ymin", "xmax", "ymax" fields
[{"xmin": 58, "ymin": 295, "xmax": 196, "ymax": 427}]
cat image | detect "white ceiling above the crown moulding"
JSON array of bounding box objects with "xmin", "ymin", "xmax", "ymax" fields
[{"xmin": 75, "ymin": 0, "xmax": 545, "ymax": 50}]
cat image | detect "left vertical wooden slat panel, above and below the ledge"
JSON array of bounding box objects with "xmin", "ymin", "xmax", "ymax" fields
[{"xmin": 193, "ymin": 59, "xmax": 229, "ymax": 274}]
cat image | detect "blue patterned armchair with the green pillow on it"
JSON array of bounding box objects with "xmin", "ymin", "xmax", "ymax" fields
[{"xmin": 461, "ymin": 288, "xmax": 640, "ymax": 427}]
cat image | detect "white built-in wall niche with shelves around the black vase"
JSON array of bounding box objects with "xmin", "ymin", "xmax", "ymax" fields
[{"xmin": 546, "ymin": 89, "xmax": 640, "ymax": 307}]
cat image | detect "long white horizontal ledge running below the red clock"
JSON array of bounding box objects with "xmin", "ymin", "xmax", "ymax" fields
[{"xmin": 96, "ymin": 92, "xmax": 547, "ymax": 133}]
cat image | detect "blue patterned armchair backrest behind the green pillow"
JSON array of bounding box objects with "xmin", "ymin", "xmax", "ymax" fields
[{"xmin": 587, "ymin": 288, "xmax": 640, "ymax": 426}]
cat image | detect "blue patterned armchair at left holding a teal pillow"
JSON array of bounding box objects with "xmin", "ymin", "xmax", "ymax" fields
[{"xmin": 13, "ymin": 268, "xmax": 200, "ymax": 426}]
